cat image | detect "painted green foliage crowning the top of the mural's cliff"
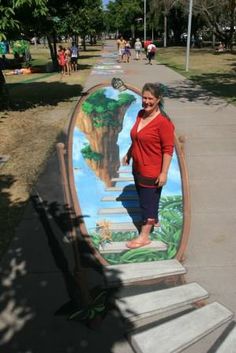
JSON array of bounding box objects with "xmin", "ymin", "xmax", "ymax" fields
[{"xmin": 82, "ymin": 89, "xmax": 135, "ymax": 128}]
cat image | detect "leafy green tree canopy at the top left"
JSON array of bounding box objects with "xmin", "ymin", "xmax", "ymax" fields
[{"xmin": 0, "ymin": 0, "xmax": 103, "ymax": 40}]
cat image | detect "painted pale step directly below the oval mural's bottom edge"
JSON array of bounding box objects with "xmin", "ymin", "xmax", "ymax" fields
[{"xmin": 104, "ymin": 259, "xmax": 186, "ymax": 286}]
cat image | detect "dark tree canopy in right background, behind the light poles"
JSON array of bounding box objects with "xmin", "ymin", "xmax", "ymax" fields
[{"xmin": 105, "ymin": 0, "xmax": 236, "ymax": 48}]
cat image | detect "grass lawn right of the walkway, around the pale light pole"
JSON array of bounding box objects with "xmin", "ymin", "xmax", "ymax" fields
[{"xmin": 157, "ymin": 47, "xmax": 236, "ymax": 104}]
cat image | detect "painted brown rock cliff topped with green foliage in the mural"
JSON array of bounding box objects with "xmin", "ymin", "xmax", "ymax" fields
[{"xmin": 77, "ymin": 89, "xmax": 135, "ymax": 186}]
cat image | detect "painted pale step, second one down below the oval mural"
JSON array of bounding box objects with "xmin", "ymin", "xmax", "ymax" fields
[{"xmin": 116, "ymin": 283, "xmax": 208, "ymax": 326}]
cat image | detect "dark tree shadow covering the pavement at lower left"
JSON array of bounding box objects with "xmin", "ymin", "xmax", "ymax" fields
[{"xmin": 0, "ymin": 182, "xmax": 136, "ymax": 353}]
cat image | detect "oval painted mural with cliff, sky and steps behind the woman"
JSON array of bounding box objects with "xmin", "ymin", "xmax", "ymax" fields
[{"xmin": 68, "ymin": 84, "xmax": 190, "ymax": 264}]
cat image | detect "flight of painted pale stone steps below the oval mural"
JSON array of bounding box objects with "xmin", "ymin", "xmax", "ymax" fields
[{"xmin": 105, "ymin": 259, "xmax": 236, "ymax": 353}]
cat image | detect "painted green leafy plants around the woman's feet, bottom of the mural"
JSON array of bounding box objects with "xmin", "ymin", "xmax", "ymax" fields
[{"xmin": 91, "ymin": 195, "xmax": 183, "ymax": 264}]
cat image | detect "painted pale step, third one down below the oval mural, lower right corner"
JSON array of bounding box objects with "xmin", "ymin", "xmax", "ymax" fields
[{"xmin": 130, "ymin": 302, "xmax": 233, "ymax": 353}]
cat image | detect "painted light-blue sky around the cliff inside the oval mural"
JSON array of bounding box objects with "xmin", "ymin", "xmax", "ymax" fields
[{"xmin": 72, "ymin": 87, "xmax": 182, "ymax": 233}]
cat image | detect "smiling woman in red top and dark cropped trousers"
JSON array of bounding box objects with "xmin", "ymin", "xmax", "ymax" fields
[{"xmin": 124, "ymin": 83, "xmax": 174, "ymax": 249}]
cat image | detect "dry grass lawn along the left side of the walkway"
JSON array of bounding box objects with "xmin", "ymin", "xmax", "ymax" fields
[{"xmin": 0, "ymin": 46, "xmax": 101, "ymax": 258}]
